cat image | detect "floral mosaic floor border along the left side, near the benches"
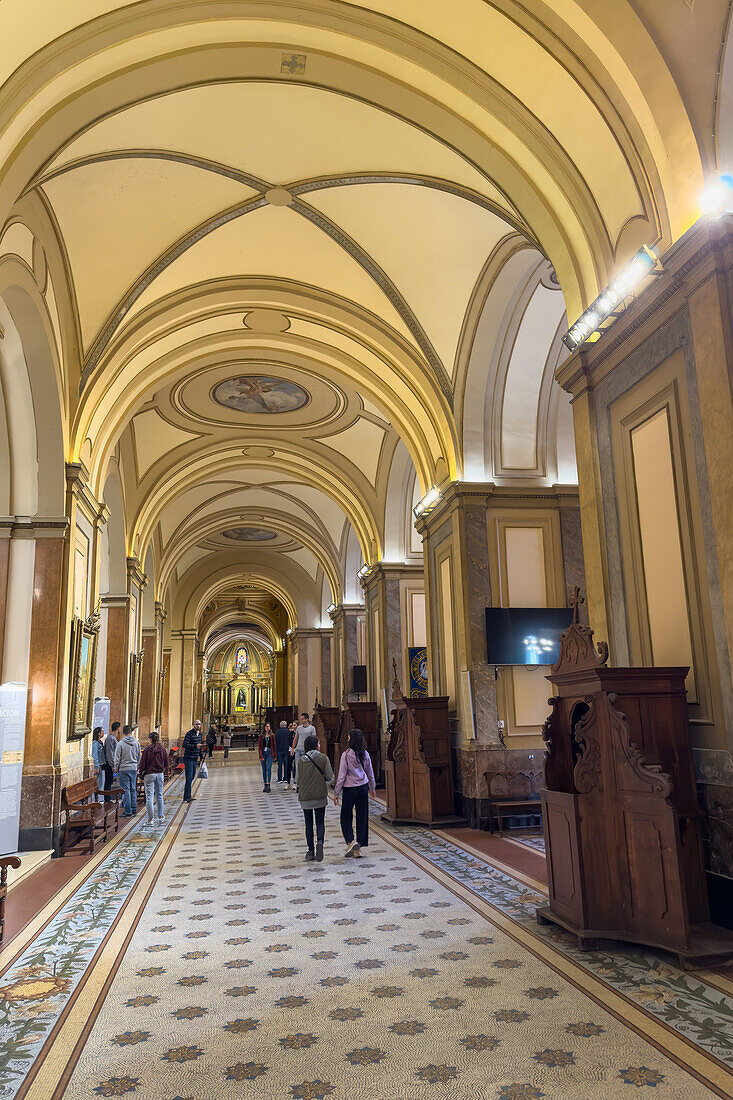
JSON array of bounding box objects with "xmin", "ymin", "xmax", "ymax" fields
[{"xmin": 0, "ymin": 778, "xmax": 183, "ymax": 1100}]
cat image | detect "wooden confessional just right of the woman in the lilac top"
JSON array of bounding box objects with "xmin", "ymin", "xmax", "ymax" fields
[{"xmin": 382, "ymin": 661, "xmax": 466, "ymax": 827}]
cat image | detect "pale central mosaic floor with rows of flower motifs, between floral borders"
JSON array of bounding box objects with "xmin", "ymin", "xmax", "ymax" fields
[{"xmin": 0, "ymin": 767, "xmax": 721, "ymax": 1100}]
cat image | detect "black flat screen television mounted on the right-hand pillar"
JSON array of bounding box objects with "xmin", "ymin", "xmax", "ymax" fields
[{"xmin": 486, "ymin": 607, "xmax": 572, "ymax": 664}]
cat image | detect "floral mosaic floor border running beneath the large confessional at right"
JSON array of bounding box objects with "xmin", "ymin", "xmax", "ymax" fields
[{"xmin": 383, "ymin": 815, "xmax": 733, "ymax": 1068}]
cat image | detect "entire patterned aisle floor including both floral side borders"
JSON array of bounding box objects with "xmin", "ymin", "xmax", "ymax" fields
[{"xmin": 0, "ymin": 765, "xmax": 733, "ymax": 1100}]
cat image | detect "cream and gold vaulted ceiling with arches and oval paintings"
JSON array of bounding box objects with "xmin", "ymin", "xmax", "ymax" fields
[{"xmin": 0, "ymin": 0, "xmax": 723, "ymax": 626}]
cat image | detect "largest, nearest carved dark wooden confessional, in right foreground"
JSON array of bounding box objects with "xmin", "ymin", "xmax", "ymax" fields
[{"xmin": 537, "ymin": 592, "xmax": 733, "ymax": 967}]
